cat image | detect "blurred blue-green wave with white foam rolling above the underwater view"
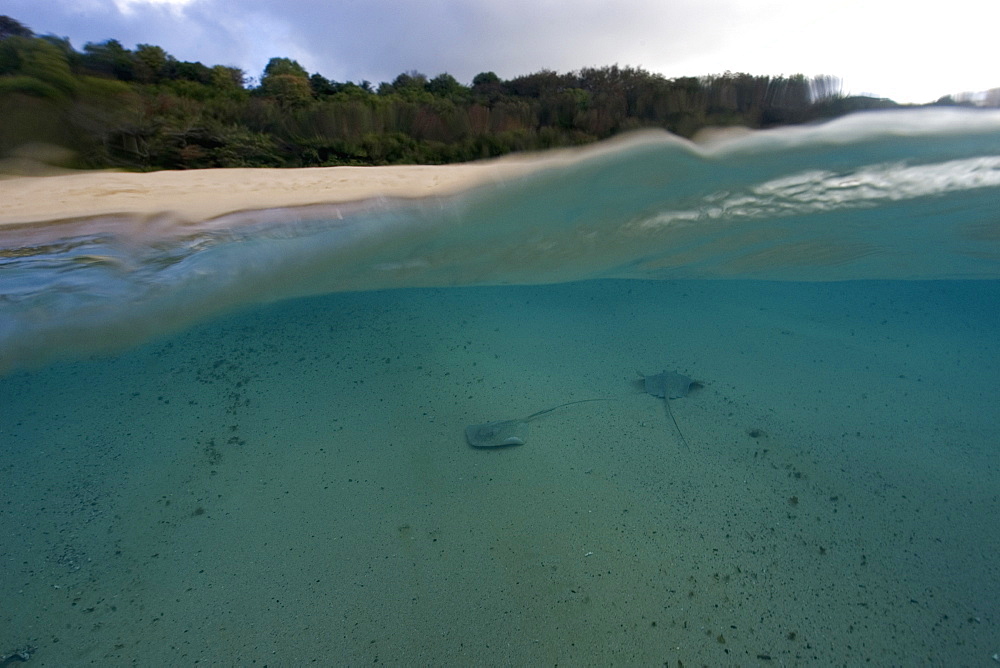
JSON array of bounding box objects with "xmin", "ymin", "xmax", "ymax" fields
[{"xmin": 0, "ymin": 110, "xmax": 1000, "ymax": 371}]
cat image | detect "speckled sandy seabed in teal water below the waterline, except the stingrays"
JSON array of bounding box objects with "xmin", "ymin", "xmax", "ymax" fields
[{"xmin": 0, "ymin": 281, "xmax": 1000, "ymax": 666}]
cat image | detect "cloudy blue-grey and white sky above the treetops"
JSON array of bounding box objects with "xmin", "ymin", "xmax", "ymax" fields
[{"xmin": 0, "ymin": 0, "xmax": 1000, "ymax": 102}]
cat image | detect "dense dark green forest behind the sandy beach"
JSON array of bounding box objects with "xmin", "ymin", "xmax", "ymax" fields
[{"xmin": 0, "ymin": 16, "xmax": 944, "ymax": 170}]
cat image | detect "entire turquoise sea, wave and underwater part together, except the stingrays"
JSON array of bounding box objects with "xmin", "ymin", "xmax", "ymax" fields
[{"xmin": 0, "ymin": 109, "xmax": 1000, "ymax": 666}]
